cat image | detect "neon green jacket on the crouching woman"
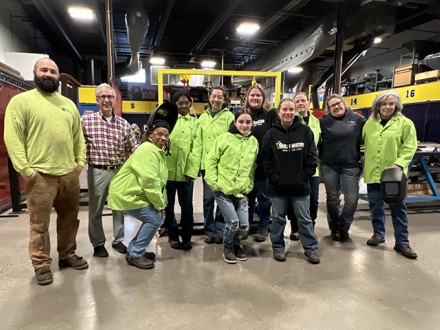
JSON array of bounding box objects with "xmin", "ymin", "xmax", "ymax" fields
[{"xmin": 108, "ymin": 142, "xmax": 168, "ymax": 211}]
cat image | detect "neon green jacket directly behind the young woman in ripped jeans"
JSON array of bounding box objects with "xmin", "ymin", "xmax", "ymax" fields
[{"xmin": 199, "ymin": 108, "xmax": 234, "ymax": 170}]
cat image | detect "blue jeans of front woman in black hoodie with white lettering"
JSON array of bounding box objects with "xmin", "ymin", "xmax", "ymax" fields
[{"xmin": 270, "ymin": 196, "xmax": 318, "ymax": 254}]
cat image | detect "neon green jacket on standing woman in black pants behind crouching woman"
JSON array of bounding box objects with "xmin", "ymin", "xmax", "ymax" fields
[{"xmin": 166, "ymin": 115, "xmax": 202, "ymax": 182}]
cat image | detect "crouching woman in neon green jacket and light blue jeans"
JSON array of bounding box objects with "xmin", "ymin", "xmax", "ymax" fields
[{"xmin": 108, "ymin": 120, "xmax": 171, "ymax": 269}]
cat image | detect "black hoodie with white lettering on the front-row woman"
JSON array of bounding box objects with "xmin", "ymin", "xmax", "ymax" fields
[{"xmin": 260, "ymin": 116, "xmax": 318, "ymax": 196}]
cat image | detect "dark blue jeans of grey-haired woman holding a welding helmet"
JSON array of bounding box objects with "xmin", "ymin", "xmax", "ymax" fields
[{"xmin": 367, "ymin": 183, "xmax": 409, "ymax": 244}]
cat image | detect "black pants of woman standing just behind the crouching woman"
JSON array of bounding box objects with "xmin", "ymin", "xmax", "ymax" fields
[{"xmin": 165, "ymin": 181, "xmax": 194, "ymax": 242}]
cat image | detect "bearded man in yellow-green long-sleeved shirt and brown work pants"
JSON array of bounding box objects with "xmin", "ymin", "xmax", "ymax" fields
[{"xmin": 4, "ymin": 58, "xmax": 88, "ymax": 285}]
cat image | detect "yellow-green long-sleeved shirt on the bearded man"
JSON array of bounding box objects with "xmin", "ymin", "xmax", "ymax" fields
[{"xmin": 4, "ymin": 89, "xmax": 86, "ymax": 177}]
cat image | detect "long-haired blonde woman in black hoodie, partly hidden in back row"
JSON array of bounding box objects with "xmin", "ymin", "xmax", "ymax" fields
[{"xmin": 243, "ymin": 84, "xmax": 278, "ymax": 242}]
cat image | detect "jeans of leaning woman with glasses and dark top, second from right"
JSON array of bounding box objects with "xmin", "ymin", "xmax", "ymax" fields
[{"xmin": 320, "ymin": 164, "xmax": 359, "ymax": 233}]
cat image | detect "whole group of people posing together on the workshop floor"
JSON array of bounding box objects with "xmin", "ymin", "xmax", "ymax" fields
[{"xmin": 5, "ymin": 58, "xmax": 417, "ymax": 285}]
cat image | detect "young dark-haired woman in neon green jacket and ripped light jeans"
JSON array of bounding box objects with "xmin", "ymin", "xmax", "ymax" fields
[{"xmin": 205, "ymin": 109, "xmax": 258, "ymax": 264}]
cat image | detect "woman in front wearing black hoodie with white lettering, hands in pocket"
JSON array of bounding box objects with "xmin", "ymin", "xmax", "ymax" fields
[{"xmin": 261, "ymin": 99, "xmax": 320, "ymax": 264}]
